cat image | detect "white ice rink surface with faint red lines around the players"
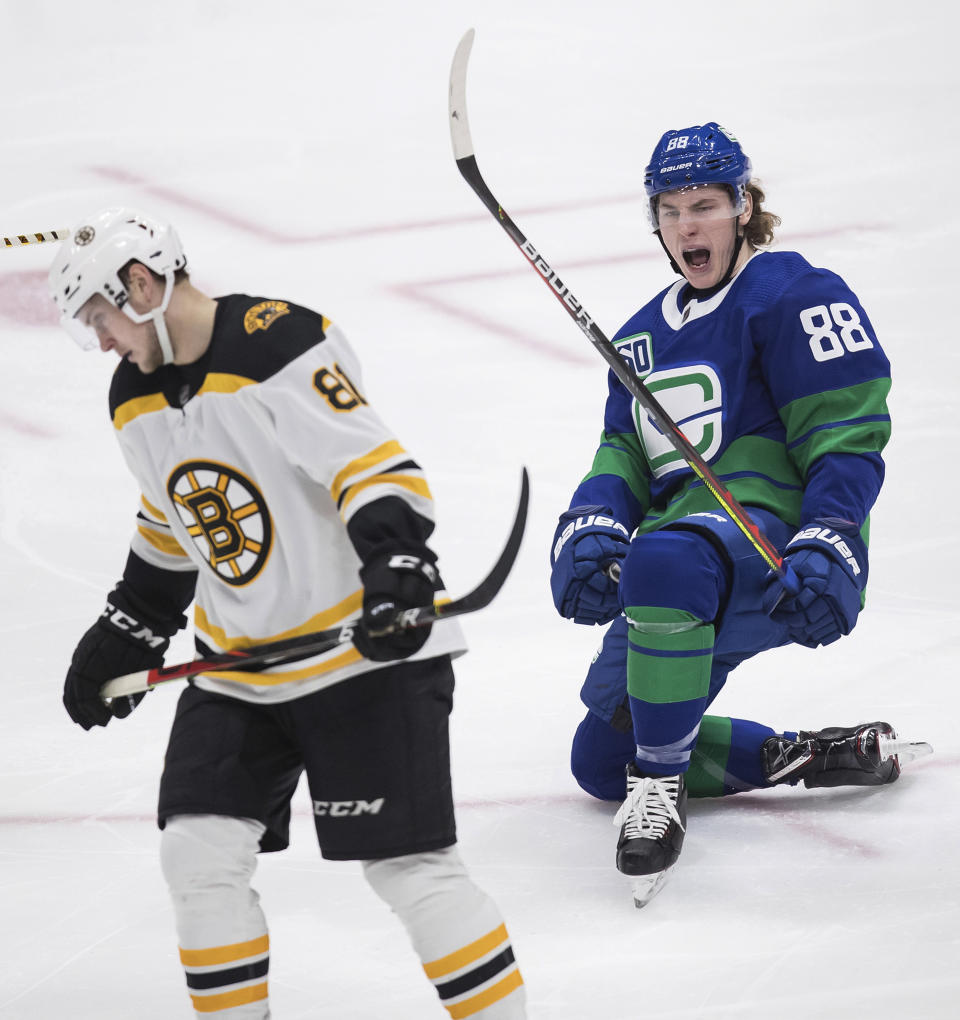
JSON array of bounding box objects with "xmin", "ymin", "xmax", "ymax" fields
[{"xmin": 0, "ymin": 0, "xmax": 960, "ymax": 1020}]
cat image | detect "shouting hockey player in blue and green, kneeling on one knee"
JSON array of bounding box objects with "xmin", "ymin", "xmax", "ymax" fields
[{"xmin": 551, "ymin": 123, "xmax": 928, "ymax": 906}]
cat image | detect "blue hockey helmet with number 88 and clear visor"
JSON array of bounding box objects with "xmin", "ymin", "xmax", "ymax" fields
[{"xmin": 644, "ymin": 120, "xmax": 752, "ymax": 231}]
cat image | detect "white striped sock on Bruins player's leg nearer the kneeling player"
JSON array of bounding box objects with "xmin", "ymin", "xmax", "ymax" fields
[{"xmin": 363, "ymin": 847, "xmax": 526, "ymax": 1020}]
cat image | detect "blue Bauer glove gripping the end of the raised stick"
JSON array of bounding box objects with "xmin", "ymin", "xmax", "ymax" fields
[{"xmin": 763, "ymin": 517, "xmax": 867, "ymax": 648}]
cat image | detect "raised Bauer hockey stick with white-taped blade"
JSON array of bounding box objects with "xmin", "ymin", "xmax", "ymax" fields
[{"xmin": 450, "ymin": 29, "xmax": 784, "ymax": 578}]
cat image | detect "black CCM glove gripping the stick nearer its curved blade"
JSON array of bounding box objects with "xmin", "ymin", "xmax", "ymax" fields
[{"xmin": 353, "ymin": 546, "xmax": 438, "ymax": 662}]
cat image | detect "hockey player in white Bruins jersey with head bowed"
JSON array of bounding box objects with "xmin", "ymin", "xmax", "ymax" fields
[{"xmin": 49, "ymin": 209, "xmax": 525, "ymax": 1020}]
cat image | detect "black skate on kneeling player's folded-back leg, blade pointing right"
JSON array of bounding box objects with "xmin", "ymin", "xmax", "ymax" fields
[{"xmin": 762, "ymin": 722, "xmax": 933, "ymax": 788}]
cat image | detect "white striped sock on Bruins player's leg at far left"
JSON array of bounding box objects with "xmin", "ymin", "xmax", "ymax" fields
[{"xmin": 160, "ymin": 815, "xmax": 270, "ymax": 1020}]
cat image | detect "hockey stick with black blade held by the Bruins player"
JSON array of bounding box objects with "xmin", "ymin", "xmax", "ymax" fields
[{"xmin": 100, "ymin": 467, "xmax": 529, "ymax": 698}]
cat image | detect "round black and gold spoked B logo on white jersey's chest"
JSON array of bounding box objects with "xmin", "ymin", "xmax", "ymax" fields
[{"xmin": 166, "ymin": 460, "xmax": 273, "ymax": 587}]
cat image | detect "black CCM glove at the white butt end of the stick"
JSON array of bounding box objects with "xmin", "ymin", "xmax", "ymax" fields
[{"xmin": 63, "ymin": 582, "xmax": 186, "ymax": 729}]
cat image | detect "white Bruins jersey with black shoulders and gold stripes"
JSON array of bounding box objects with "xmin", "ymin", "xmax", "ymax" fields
[{"xmin": 110, "ymin": 295, "xmax": 465, "ymax": 703}]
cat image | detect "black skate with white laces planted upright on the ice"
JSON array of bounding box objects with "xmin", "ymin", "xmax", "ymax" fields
[{"xmin": 613, "ymin": 762, "xmax": 687, "ymax": 907}]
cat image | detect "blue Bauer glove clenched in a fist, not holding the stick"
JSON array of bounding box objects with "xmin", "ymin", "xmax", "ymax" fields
[{"xmin": 550, "ymin": 506, "xmax": 629, "ymax": 623}]
